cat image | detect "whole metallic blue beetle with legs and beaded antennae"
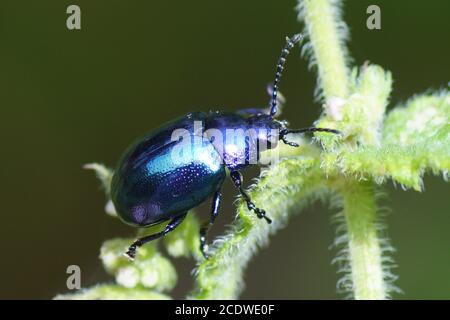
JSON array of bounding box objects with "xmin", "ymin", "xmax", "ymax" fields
[{"xmin": 111, "ymin": 34, "xmax": 339, "ymax": 259}]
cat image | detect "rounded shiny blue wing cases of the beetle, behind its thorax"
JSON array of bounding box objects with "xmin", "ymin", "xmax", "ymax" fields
[{"xmin": 112, "ymin": 132, "xmax": 226, "ymax": 226}]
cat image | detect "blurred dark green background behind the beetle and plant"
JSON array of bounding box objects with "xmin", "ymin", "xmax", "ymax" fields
[{"xmin": 0, "ymin": 0, "xmax": 450, "ymax": 299}]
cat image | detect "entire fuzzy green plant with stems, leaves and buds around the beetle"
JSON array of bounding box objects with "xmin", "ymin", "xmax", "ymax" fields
[{"xmin": 57, "ymin": 0, "xmax": 450, "ymax": 299}]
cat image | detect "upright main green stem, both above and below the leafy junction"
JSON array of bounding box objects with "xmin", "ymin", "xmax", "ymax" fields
[{"xmin": 298, "ymin": 0, "xmax": 386, "ymax": 299}]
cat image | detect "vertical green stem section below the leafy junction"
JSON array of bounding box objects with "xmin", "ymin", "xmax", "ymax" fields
[{"xmin": 341, "ymin": 182, "xmax": 386, "ymax": 300}]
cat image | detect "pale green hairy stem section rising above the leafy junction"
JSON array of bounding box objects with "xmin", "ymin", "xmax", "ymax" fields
[{"xmin": 298, "ymin": 0, "xmax": 349, "ymax": 98}]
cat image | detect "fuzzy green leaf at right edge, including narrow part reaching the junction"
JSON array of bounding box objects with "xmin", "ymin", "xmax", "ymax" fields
[{"xmin": 322, "ymin": 92, "xmax": 450, "ymax": 191}]
